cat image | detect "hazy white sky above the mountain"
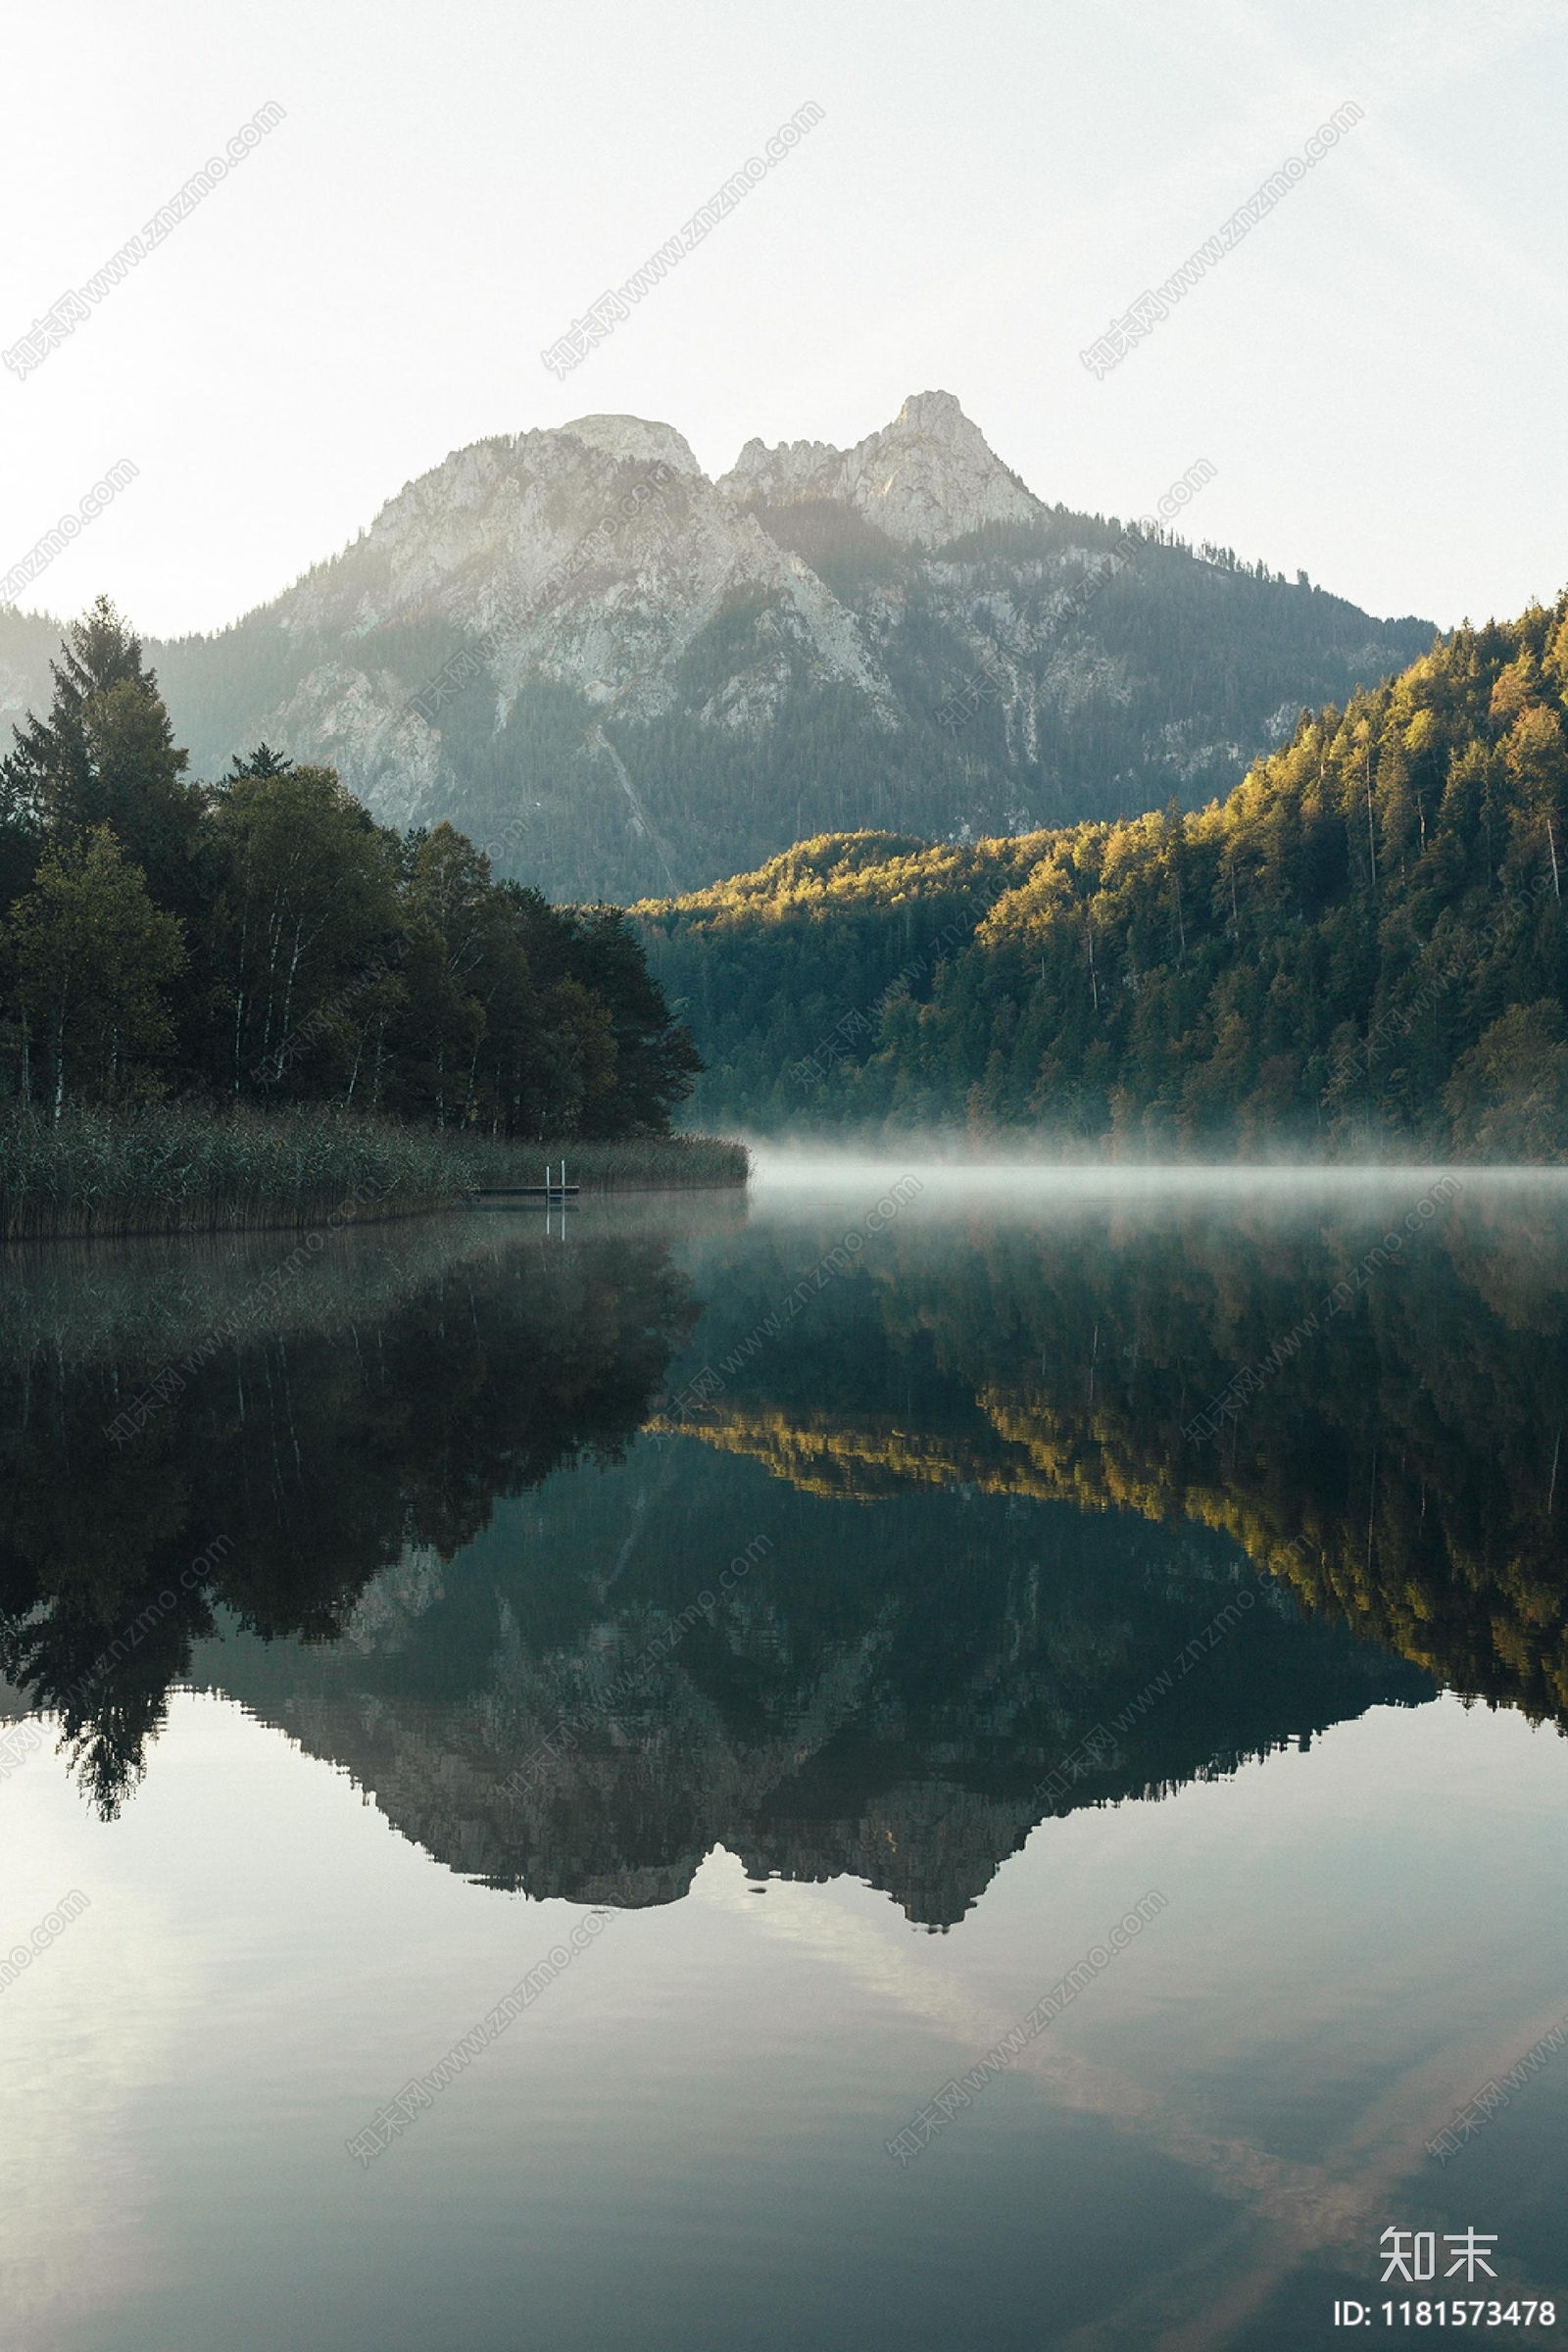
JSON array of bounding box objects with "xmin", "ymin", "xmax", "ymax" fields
[{"xmin": 0, "ymin": 0, "xmax": 1568, "ymax": 635}]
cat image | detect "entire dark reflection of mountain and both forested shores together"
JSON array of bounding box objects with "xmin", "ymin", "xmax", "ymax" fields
[{"xmin": 0, "ymin": 1200, "xmax": 1568, "ymax": 1924}]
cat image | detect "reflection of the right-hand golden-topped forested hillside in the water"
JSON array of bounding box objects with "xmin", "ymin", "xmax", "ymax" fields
[{"xmin": 682, "ymin": 1181, "xmax": 1568, "ymax": 1722}]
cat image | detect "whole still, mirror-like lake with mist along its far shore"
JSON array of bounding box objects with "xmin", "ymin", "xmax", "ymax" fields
[{"xmin": 0, "ymin": 1154, "xmax": 1568, "ymax": 2352}]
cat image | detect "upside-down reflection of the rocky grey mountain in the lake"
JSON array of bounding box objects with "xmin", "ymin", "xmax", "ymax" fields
[{"xmin": 197, "ymin": 1442, "xmax": 1432, "ymax": 1927}]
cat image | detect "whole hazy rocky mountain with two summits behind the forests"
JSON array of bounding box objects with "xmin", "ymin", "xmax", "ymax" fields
[{"xmin": 0, "ymin": 393, "xmax": 1432, "ymax": 899}]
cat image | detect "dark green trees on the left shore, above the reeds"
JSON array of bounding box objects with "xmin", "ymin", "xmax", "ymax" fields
[{"xmin": 0, "ymin": 598, "xmax": 701, "ymax": 1139}]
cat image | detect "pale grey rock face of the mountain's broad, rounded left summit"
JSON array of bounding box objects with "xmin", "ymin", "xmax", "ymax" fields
[{"xmin": 196, "ymin": 416, "xmax": 896, "ymax": 825}]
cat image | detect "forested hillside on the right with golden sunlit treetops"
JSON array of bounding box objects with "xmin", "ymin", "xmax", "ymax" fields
[{"xmin": 637, "ymin": 578, "xmax": 1568, "ymax": 1159}]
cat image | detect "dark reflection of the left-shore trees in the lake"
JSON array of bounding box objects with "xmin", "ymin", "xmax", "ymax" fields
[{"xmin": 0, "ymin": 1218, "xmax": 694, "ymax": 1811}]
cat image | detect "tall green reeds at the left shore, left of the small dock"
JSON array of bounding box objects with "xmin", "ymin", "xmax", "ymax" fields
[{"xmin": 0, "ymin": 1103, "xmax": 472, "ymax": 1242}]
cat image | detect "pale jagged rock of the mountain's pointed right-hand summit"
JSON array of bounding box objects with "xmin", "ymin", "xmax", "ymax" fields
[{"xmin": 717, "ymin": 393, "xmax": 1046, "ymax": 548}]
